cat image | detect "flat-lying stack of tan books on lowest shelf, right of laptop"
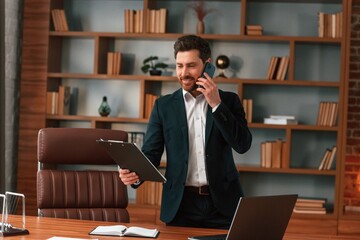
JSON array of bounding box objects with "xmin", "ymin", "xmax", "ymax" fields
[{"xmin": 294, "ymin": 198, "xmax": 326, "ymax": 214}]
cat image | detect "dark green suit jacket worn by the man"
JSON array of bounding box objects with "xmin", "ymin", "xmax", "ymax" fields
[{"xmin": 142, "ymin": 89, "xmax": 252, "ymax": 223}]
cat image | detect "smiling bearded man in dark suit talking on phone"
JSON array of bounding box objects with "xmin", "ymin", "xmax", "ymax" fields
[{"xmin": 119, "ymin": 35, "xmax": 252, "ymax": 229}]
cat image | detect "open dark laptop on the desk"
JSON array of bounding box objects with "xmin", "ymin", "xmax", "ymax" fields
[{"xmin": 188, "ymin": 194, "xmax": 298, "ymax": 240}]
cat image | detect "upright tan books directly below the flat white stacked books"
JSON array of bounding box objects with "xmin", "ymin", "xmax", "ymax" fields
[{"xmin": 260, "ymin": 139, "xmax": 289, "ymax": 168}]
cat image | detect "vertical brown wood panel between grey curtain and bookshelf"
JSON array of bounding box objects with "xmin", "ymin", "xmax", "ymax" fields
[{"xmin": 17, "ymin": 0, "xmax": 50, "ymax": 215}]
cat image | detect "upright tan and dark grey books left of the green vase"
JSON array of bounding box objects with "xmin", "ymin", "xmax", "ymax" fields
[{"xmin": 46, "ymin": 85, "xmax": 79, "ymax": 115}]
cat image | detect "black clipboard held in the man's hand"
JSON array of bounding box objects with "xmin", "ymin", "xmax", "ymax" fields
[{"xmin": 96, "ymin": 139, "xmax": 166, "ymax": 183}]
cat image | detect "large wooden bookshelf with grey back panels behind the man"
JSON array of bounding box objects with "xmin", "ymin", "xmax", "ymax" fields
[{"xmin": 18, "ymin": 0, "xmax": 358, "ymax": 234}]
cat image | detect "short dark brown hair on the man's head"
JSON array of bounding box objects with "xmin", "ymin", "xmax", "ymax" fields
[{"xmin": 174, "ymin": 35, "xmax": 211, "ymax": 62}]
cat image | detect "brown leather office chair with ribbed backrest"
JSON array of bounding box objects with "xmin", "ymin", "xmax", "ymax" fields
[{"xmin": 37, "ymin": 128, "xmax": 130, "ymax": 222}]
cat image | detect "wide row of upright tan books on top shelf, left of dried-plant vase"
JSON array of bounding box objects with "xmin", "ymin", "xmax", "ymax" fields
[{"xmin": 124, "ymin": 8, "xmax": 167, "ymax": 33}]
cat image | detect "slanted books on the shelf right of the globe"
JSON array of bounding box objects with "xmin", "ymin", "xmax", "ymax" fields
[{"xmin": 266, "ymin": 56, "xmax": 290, "ymax": 81}]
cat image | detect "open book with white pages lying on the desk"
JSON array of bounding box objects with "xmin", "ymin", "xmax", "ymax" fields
[{"xmin": 89, "ymin": 225, "xmax": 159, "ymax": 238}]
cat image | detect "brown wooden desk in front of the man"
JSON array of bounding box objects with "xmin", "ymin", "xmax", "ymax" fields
[{"xmin": 4, "ymin": 216, "xmax": 360, "ymax": 240}]
